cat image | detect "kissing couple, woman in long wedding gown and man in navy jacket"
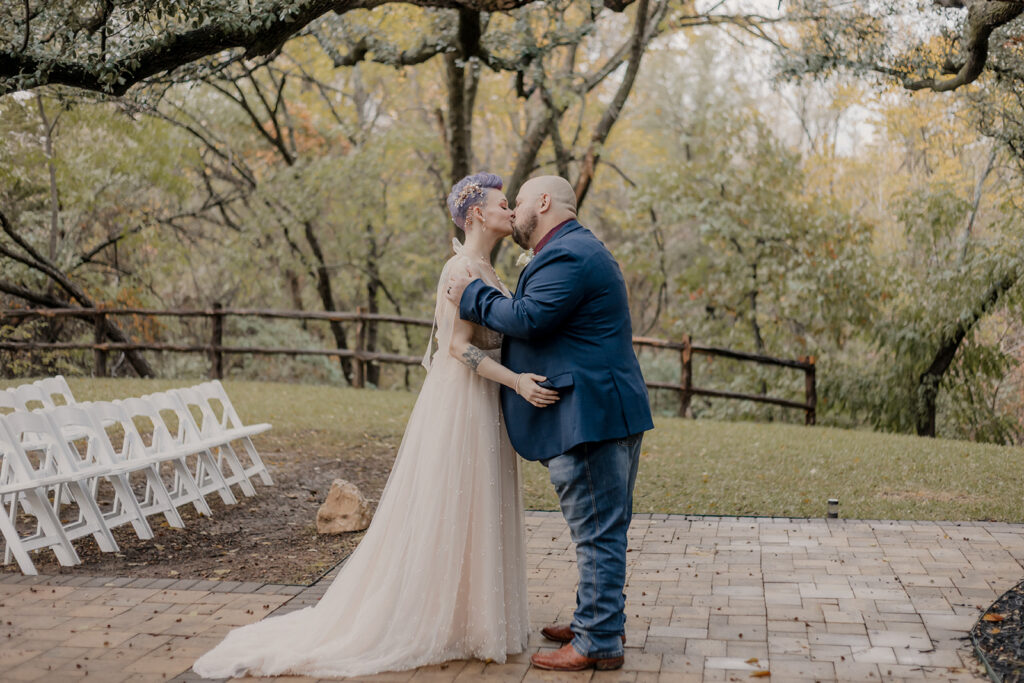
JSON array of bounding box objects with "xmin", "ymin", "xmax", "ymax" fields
[{"xmin": 193, "ymin": 173, "xmax": 653, "ymax": 678}]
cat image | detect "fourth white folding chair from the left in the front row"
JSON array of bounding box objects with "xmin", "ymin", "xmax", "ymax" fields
[{"xmin": 79, "ymin": 401, "xmax": 184, "ymax": 528}]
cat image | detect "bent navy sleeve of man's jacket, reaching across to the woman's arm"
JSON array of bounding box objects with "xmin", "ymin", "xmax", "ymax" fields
[{"xmin": 459, "ymin": 252, "xmax": 585, "ymax": 339}]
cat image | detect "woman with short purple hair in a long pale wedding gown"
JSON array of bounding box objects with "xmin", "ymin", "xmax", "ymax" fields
[{"xmin": 193, "ymin": 173, "xmax": 558, "ymax": 678}]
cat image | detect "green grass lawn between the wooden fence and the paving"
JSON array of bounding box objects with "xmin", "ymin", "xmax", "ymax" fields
[{"xmin": 9, "ymin": 378, "xmax": 1024, "ymax": 522}]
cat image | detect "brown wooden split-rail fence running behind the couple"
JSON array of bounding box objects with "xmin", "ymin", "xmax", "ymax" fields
[{"xmin": 0, "ymin": 304, "xmax": 817, "ymax": 425}]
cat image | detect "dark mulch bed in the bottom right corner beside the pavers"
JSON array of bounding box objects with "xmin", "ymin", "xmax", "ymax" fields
[{"xmin": 971, "ymin": 581, "xmax": 1024, "ymax": 683}]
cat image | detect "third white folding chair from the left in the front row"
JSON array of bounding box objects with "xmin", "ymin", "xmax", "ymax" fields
[{"xmin": 42, "ymin": 404, "xmax": 153, "ymax": 540}]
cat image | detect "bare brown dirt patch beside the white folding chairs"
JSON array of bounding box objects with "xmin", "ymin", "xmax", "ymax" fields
[{"xmin": 2, "ymin": 440, "xmax": 397, "ymax": 585}]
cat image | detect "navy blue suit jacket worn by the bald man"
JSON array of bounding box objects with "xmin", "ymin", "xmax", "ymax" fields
[{"xmin": 459, "ymin": 220, "xmax": 654, "ymax": 460}]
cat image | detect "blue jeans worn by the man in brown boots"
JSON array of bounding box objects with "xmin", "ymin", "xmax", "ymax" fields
[{"xmin": 544, "ymin": 434, "xmax": 643, "ymax": 659}]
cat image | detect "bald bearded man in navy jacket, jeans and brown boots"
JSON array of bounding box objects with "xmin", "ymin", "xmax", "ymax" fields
[{"xmin": 447, "ymin": 176, "xmax": 653, "ymax": 671}]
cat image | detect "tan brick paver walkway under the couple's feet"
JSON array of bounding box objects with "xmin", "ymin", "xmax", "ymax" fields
[{"xmin": 0, "ymin": 512, "xmax": 1024, "ymax": 683}]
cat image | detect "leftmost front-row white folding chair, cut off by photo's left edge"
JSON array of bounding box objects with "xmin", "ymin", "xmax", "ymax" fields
[{"xmin": 0, "ymin": 417, "xmax": 82, "ymax": 575}]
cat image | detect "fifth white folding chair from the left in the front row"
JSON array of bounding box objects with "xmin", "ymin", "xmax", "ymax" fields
[{"xmin": 114, "ymin": 397, "xmax": 211, "ymax": 517}]
